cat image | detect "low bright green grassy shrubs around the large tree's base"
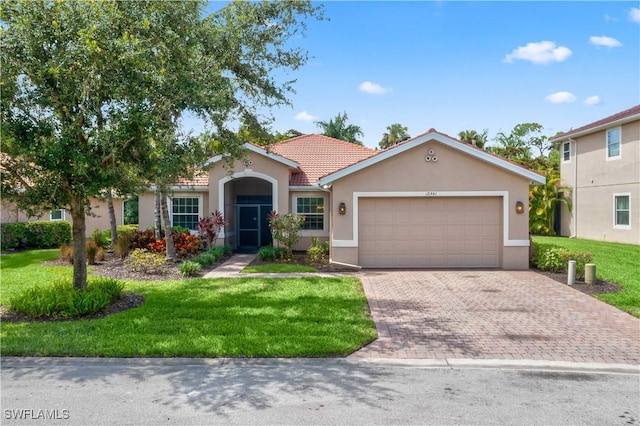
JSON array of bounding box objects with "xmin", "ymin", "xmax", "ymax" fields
[{"xmin": 9, "ymin": 278, "xmax": 124, "ymax": 318}]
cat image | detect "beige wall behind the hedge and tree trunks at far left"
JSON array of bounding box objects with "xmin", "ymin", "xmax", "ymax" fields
[{"xmin": 2, "ymin": 198, "xmax": 124, "ymax": 237}]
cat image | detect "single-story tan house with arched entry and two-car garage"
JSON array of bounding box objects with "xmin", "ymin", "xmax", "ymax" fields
[{"xmin": 139, "ymin": 129, "xmax": 545, "ymax": 269}]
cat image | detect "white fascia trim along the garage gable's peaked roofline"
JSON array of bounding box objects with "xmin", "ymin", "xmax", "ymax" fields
[{"xmin": 318, "ymin": 129, "xmax": 546, "ymax": 186}]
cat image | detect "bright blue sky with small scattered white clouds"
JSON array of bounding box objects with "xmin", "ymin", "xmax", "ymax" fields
[{"xmin": 193, "ymin": 1, "xmax": 640, "ymax": 147}]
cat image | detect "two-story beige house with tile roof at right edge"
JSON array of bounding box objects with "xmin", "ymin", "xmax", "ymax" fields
[{"xmin": 551, "ymin": 105, "xmax": 640, "ymax": 244}]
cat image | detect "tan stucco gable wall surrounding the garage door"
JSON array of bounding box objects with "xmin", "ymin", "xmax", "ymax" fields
[{"xmin": 331, "ymin": 141, "xmax": 529, "ymax": 269}]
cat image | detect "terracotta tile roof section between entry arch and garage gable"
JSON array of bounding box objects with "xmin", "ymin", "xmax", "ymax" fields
[{"xmin": 270, "ymin": 134, "xmax": 379, "ymax": 186}]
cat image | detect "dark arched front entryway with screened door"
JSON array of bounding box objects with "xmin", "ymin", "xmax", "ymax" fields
[{"xmin": 223, "ymin": 176, "xmax": 274, "ymax": 252}]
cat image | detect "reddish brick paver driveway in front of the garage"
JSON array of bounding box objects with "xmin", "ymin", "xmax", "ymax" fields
[{"xmin": 351, "ymin": 270, "xmax": 640, "ymax": 365}]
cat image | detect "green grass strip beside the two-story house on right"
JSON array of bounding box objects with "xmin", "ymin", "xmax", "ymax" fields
[{"xmin": 533, "ymin": 236, "xmax": 640, "ymax": 318}]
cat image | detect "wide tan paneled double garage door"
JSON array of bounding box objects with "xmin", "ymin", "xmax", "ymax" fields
[{"xmin": 358, "ymin": 197, "xmax": 502, "ymax": 268}]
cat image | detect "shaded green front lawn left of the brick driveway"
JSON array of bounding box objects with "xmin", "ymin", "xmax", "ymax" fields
[{"xmin": 0, "ymin": 252, "xmax": 376, "ymax": 357}]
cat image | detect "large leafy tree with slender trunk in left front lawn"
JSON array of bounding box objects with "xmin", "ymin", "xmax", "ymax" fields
[{"xmin": 0, "ymin": 0, "xmax": 321, "ymax": 288}]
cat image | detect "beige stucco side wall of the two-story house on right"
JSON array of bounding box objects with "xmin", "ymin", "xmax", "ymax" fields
[{"xmin": 560, "ymin": 121, "xmax": 640, "ymax": 244}]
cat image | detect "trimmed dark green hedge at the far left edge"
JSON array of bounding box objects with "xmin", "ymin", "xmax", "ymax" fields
[{"xmin": 1, "ymin": 220, "xmax": 71, "ymax": 249}]
